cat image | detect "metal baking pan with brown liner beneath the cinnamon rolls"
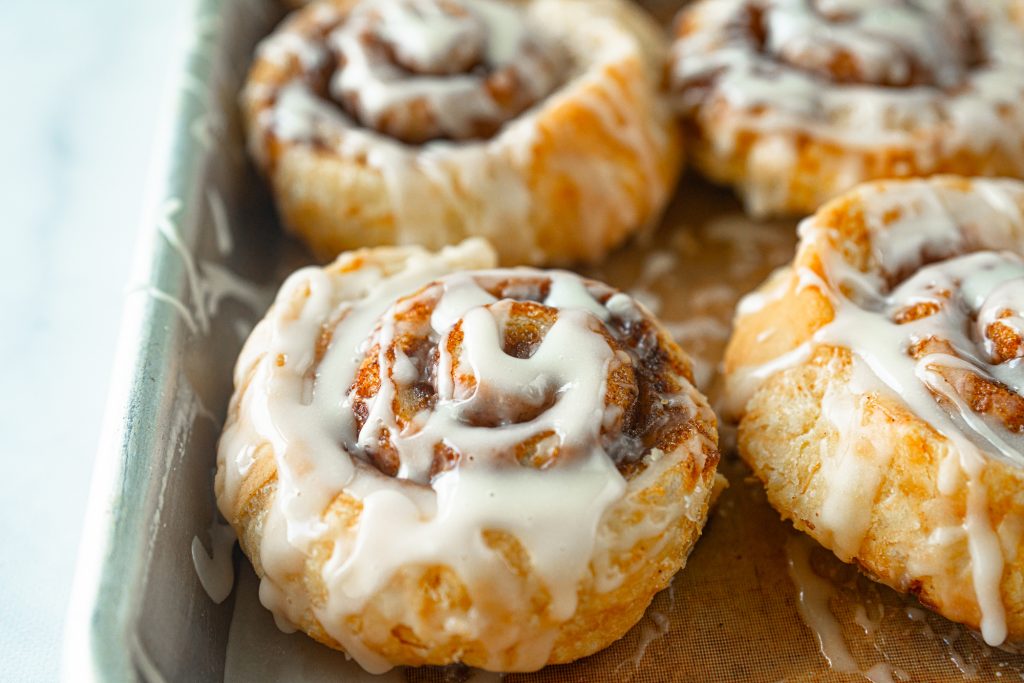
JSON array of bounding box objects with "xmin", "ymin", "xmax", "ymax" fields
[{"xmin": 63, "ymin": 0, "xmax": 1024, "ymax": 683}]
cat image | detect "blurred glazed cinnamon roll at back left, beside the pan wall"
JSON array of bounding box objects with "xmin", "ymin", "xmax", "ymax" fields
[{"xmin": 243, "ymin": 0, "xmax": 680, "ymax": 264}]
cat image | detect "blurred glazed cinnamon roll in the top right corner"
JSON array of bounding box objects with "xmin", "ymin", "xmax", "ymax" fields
[{"xmin": 671, "ymin": 0, "xmax": 1024, "ymax": 216}]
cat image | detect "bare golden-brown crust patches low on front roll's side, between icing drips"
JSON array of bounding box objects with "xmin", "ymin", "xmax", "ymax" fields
[{"xmin": 231, "ymin": 440, "xmax": 718, "ymax": 668}]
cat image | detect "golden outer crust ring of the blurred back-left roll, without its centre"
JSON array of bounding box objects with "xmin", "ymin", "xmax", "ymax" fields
[{"xmin": 242, "ymin": 0, "xmax": 682, "ymax": 264}]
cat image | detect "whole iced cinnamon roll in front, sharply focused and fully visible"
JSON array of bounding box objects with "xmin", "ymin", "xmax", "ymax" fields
[{"xmin": 216, "ymin": 241, "xmax": 719, "ymax": 672}]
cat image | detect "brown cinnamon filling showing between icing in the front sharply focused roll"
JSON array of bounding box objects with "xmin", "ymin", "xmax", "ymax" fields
[{"xmin": 350, "ymin": 276, "xmax": 694, "ymax": 478}]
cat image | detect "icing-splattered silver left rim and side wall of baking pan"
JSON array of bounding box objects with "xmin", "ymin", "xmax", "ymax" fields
[{"xmin": 63, "ymin": 0, "xmax": 288, "ymax": 681}]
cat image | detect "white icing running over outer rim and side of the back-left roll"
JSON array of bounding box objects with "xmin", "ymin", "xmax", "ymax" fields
[{"xmin": 244, "ymin": 0, "xmax": 672, "ymax": 262}]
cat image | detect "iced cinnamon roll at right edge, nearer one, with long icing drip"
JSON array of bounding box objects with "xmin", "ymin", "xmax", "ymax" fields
[{"xmin": 725, "ymin": 177, "xmax": 1024, "ymax": 648}]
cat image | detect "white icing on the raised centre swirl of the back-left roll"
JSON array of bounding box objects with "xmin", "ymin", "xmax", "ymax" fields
[{"xmin": 327, "ymin": 0, "xmax": 559, "ymax": 139}]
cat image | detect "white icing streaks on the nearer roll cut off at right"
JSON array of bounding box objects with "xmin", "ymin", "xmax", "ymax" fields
[{"xmin": 729, "ymin": 180, "xmax": 1024, "ymax": 645}]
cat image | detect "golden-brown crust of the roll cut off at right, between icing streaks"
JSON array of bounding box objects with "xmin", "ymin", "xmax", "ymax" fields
[{"xmin": 725, "ymin": 178, "xmax": 1024, "ymax": 646}]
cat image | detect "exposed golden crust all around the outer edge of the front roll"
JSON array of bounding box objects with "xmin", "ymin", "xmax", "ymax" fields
[{"xmin": 217, "ymin": 242, "xmax": 718, "ymax": 670}]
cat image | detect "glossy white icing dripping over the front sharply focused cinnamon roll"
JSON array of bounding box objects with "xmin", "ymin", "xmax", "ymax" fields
[{"xmin": 218, "ymin": 242, "xmax": 708, "ymax": 672}]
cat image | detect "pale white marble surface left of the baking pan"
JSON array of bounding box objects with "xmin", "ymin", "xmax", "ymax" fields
[{"xmin": 0, "ymin": 0, "xmax": 184, "ymax": 682}]
